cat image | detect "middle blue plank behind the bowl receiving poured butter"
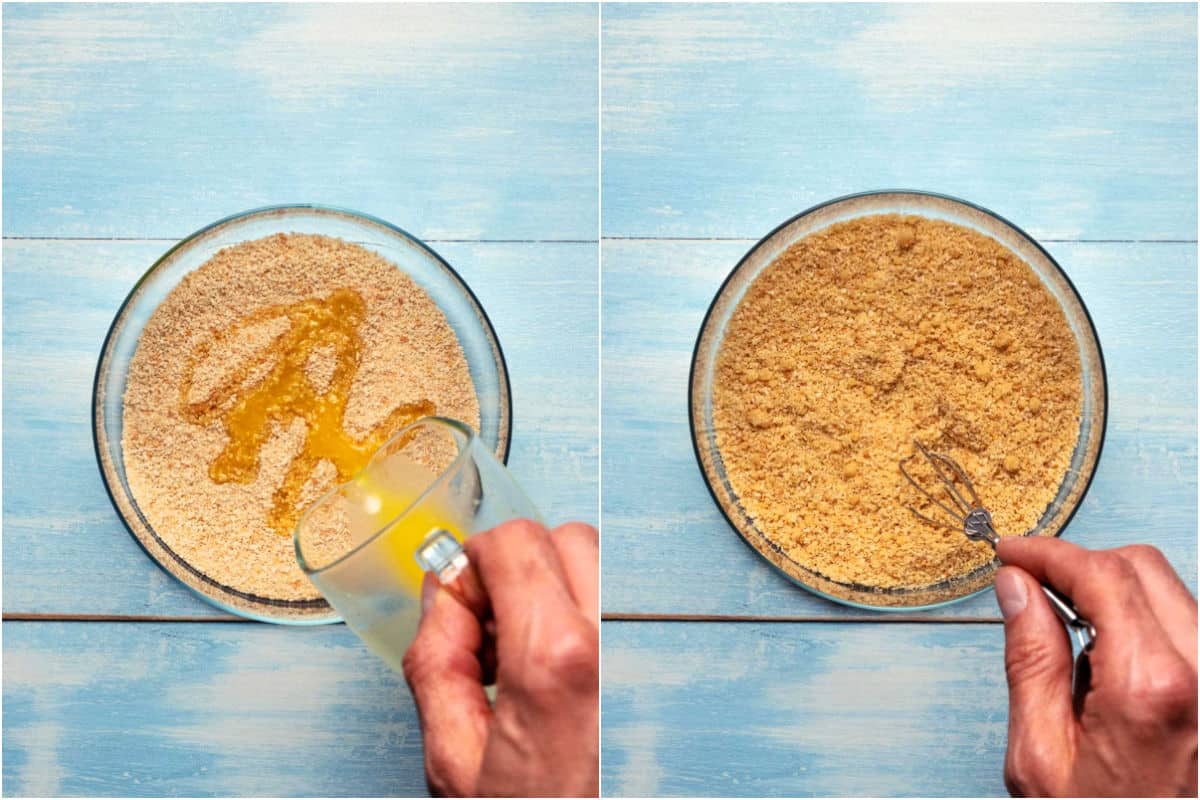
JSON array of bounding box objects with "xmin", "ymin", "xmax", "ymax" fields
[{"xmin": 4, "ymin": 241, "xmax": 599, "ymax": 615}]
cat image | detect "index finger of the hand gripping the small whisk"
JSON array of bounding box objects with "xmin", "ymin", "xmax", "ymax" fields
[{"xmin": 996, "ymin": 536, "xmax": 1164, "ymax": 650}]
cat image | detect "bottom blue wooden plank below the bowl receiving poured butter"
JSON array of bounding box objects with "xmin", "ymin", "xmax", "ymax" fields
[{"xmin": 4, "ymin": 622, "xmax": 426, "ymax": 796}]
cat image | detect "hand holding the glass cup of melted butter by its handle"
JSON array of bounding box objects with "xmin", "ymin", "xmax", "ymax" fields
[{"xmin": 403, "ymin": 519, "xmax": 600, "ymax": 796}]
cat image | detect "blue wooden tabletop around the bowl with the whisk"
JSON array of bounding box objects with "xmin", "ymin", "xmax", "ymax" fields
[{"xmin": 601, "ymin": 4, "xmax": 1196, "ymax": 796}]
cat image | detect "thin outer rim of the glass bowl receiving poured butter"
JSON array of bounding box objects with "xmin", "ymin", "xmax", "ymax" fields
[{"xmin": 91, "ymin": 203, "xmax": 514, "ymax": 625}]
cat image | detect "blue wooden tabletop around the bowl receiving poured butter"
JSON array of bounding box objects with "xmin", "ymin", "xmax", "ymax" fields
[{"xmin": 2, "ymin": 5, "xmax": 599, "ymax": 795}]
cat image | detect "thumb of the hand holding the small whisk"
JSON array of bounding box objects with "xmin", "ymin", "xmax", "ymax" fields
[{"xmin": 996, "ymin": 566, "xmax": 1076, "ymax": 796}]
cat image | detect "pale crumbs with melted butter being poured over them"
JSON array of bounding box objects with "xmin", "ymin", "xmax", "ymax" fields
[{"xmin": 122, "ymin": 234, "xmax": 479, "ymax": 601}]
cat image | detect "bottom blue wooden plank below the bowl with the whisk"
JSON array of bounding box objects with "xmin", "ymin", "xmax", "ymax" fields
[{"xmin": 601, "ymin": 622, "xmax": 1007, "ymax": 796}]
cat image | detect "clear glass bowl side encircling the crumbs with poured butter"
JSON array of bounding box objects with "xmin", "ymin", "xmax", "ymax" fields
[{"xmin": 92, "ymin": 205, "xmax": 512, "ymax": 625}]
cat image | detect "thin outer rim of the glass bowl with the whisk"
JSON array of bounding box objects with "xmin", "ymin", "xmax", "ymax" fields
[{"xmin": 688, "ymin": 188, "xmax": 1109, "ymax": 614}]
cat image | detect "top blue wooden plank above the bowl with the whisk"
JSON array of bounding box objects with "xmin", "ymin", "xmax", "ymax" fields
[{"xmin": 601, "ymin": 4, "xmax": 1196, "ymax": 240}]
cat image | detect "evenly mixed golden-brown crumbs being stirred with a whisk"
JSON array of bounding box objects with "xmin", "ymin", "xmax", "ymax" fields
[{"xmin": 713, "ymin": 215, "xmax": 1082, "ymax": 588}]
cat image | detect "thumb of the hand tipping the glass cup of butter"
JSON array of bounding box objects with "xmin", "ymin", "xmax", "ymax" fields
[{"xmin": 403, "ymin": 573, "xmax": 492, "ymax": 796}]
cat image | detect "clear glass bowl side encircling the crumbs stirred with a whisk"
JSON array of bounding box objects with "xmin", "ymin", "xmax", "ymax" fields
[{"xmin": 688, "ymin": 191, "xmax": 1108, "ymax": 610}]
